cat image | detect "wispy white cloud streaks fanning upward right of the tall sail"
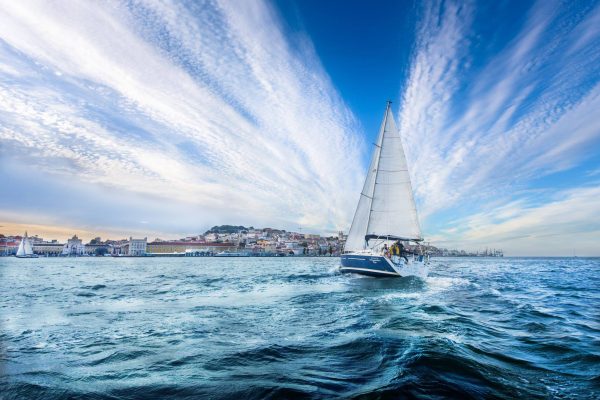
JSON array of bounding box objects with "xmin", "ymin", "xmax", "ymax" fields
[{"xmin": 399, "ymin": 1, "xmax": 600, "ymax": 253}]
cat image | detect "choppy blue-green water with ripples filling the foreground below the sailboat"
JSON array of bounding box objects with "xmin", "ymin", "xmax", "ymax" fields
[{"xmin": 0, "ymin": 257, "xmax": 600, "ymax": 399}]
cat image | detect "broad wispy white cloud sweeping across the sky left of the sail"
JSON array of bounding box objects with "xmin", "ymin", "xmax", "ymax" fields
[{"xmin": 0, "ymin": 1, "xmax": 362, "ymax": 233}]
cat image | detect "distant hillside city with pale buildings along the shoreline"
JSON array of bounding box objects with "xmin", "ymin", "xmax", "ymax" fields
[{"xmin": 0, "ymin": 225, "xmax": 504, "ymax": 257}]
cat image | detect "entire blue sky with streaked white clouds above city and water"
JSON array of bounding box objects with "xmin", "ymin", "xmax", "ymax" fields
[{"xmin": 0, "ymin": 0, "xmax": 600, "ymax": 255}]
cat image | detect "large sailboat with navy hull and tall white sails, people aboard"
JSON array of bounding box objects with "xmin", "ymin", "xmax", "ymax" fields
[{"xmin": 340, "ymin": 101, "xmax": 429, "ymax": 277}]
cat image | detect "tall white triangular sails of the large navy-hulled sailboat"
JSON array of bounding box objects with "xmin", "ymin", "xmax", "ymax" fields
[{"xmin": 344, "ymin": 102, "xmax": 422, "ymax": 251}]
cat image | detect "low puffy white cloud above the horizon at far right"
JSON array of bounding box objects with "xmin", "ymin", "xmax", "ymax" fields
[{"xmin": 437, "ymin": 187, "xmax": 600, "ymax": 256}]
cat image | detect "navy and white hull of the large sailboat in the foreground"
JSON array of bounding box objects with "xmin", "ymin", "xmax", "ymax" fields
[{"xmin": 340, "ymin": 253, "xmax": 428, "ymax": 278}]
